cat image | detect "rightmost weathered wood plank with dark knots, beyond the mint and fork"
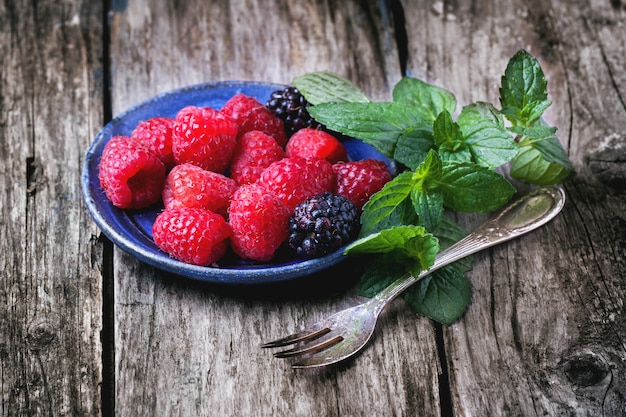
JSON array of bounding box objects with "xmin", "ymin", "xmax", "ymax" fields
[{"xmin": 403, "ymin": 1, "xmax": 626, "ymax": 416}]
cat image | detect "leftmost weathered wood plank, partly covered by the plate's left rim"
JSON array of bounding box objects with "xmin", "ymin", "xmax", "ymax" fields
[{"xmin": 0, "ymin": 1, "xmax": 102, "ymax": 416}]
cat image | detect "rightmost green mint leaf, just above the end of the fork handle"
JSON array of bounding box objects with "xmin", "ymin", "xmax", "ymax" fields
[{"xmin": 510, "ymin": 136, "xmax": 574, "ymax": 185}]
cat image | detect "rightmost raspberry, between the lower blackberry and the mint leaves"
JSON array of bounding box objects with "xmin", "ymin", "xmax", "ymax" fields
[{"xmin": 332, "ymin": 159, "xmax": 391, "ymax": 209}]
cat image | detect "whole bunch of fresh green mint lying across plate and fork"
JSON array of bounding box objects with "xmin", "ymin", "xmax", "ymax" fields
[{"xmin": 294, "ymin": 50, "xmax": 574, "ymax": 324}]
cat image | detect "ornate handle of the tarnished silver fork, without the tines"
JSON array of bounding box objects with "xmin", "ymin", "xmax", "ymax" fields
[{"xmin": 370, "ymin": 185, "xmax": 565, "ymax": 313}]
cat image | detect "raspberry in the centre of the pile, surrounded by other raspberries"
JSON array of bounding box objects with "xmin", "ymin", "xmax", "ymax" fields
[{"xmin": 230, "ymin": 130, "xmax": 285, "ymax": 185}]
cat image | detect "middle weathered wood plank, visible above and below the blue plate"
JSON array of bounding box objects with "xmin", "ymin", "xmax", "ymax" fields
[{"xmin": 112, "ymin": 1, "xmax": 440, "ymax": 416}]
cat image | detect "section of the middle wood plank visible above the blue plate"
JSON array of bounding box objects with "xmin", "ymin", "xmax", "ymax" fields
[{"xmin": 111, "ymin": 1, "xmax": 400, "ymax": 100}]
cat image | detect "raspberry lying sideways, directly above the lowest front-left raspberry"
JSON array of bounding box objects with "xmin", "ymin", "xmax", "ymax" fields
[{"xmin": 163, "ymin": 164, "xmax": 237, "ymax": 216}]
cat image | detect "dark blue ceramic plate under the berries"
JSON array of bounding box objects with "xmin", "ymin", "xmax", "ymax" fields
[{"xmin": 81, "ymin": 81, "xmax": 391, "ymax": 284}]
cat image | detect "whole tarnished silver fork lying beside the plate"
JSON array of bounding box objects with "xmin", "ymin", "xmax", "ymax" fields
[{"xmin": 261, "ymin": 186, "xmax": 565, "ymax": 368}]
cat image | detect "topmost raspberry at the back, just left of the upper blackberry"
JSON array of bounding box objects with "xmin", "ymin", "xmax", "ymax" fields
[{"xmin": 220, "ymin": 94, "xmax": 287, "ymax": 148}]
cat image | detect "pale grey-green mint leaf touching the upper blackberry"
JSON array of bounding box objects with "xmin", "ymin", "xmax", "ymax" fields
[{"xmin": 292, "ymin": 71, "xmax": 371, "ymax": 105}]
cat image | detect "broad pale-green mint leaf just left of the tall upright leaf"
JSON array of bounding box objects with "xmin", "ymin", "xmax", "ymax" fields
[{"xmin": 457, "ymin": 102, "xmax": 519, "ymax": 169}]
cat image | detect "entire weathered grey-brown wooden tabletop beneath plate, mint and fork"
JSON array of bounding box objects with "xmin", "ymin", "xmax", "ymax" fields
[{"xmin": 0, "ymin": 0, "xmax": 626, "ymax": 417}]
